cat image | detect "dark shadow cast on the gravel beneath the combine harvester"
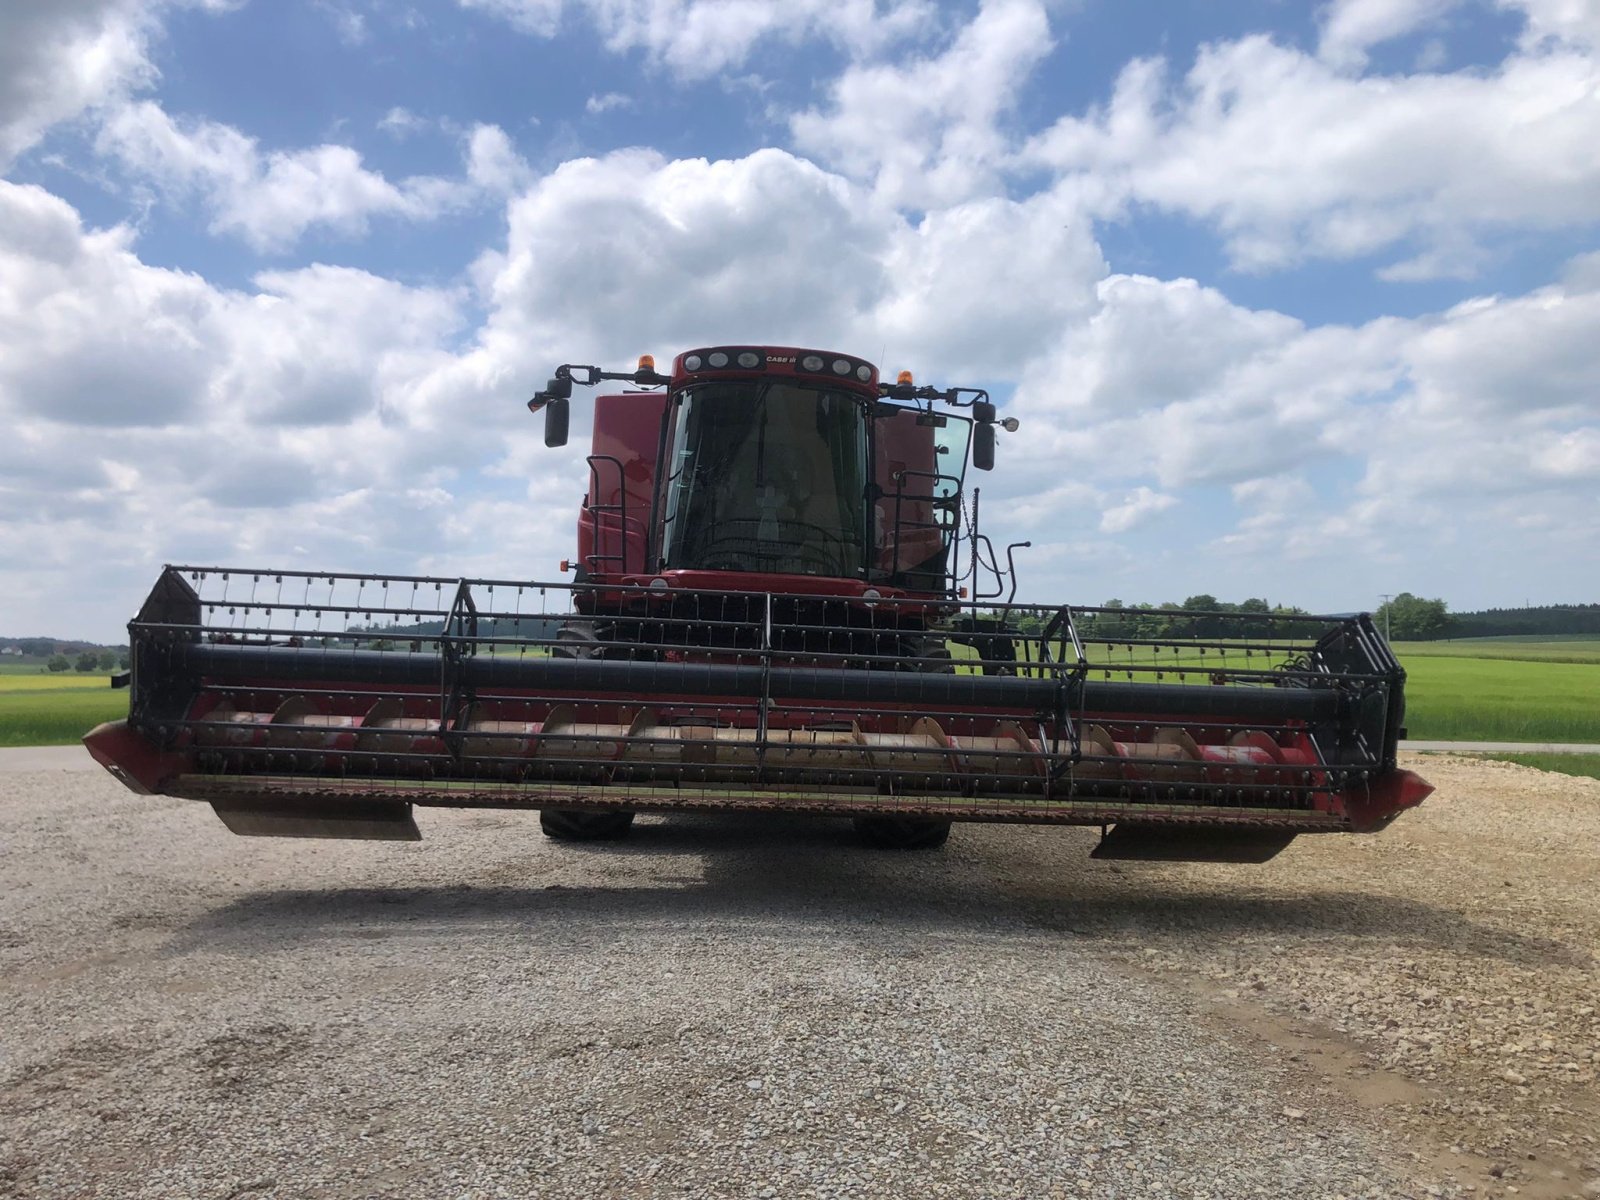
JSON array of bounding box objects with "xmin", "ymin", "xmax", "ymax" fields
[{"xmin": 166, "ymin": 814, "xmax": 1574, "ymax": 963}]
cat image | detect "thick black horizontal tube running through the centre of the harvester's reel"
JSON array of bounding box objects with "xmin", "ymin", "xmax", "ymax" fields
[{"xmin": 149, "ymin": 642, "xmax": 1341, "ymax": 722}]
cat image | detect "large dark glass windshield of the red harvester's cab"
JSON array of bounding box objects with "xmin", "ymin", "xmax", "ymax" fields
[{"xmin": 661, "ymin": 379, "xmax": 867, "ymax": 578}]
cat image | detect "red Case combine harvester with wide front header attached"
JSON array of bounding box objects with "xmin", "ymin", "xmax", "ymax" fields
[{"xmin": 85, "ymin": 346, "xmax": 1432, "ymax": 861}]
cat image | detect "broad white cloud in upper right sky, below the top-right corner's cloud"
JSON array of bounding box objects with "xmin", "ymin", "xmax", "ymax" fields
[{"xmin": 1019, "ymin": 37, "xmax": 1600, "ymax": 278}]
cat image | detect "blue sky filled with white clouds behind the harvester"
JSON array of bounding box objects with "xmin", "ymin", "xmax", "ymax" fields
[{"xmin": 0, "ymin": 0, "xmax": 1600, "ymax": 640}]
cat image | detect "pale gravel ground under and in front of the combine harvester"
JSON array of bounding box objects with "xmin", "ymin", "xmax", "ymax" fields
[{"xmin": 0, "ymin": 758, "xmax": 1600, "ymax": 1198}]
